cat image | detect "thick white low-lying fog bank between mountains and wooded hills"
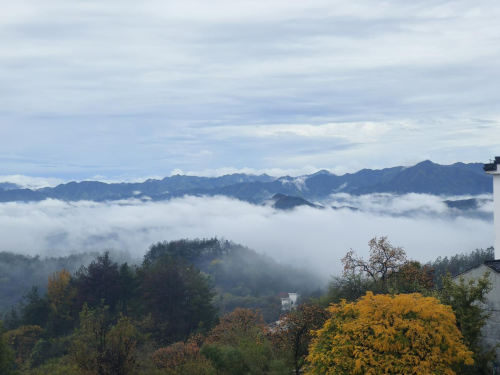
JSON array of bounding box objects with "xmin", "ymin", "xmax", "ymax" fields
[{"xmin": 0, "ymin": 194, "xmax": 493, "ymax": 276}]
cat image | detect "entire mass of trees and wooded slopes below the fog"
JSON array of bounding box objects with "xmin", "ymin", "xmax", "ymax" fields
[{"xmin": 0, "ymin": 238, "xmax": 492, "ymax": 375}]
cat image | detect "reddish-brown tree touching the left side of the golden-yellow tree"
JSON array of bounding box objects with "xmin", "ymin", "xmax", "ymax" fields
[{"xmin": 269, "ymin": 303, "xmax": 329, "ymax": 375}]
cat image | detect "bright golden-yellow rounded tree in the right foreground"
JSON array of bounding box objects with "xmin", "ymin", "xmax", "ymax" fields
[{"xmin": 307, "ymin": 292, "xmax": 474, "ymax": 375}]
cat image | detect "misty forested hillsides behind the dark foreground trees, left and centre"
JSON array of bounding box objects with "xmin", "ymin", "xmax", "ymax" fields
[{"xmin": 0, "ymin": 238, "xmax": 325, "ymax": 321}]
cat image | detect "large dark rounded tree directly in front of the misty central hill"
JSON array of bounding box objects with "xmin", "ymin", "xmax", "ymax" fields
[{"xmin": 140, "ymin": 257, "xmax": 216, "ymax": 343}]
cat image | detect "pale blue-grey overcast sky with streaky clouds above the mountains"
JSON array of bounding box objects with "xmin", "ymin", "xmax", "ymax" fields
[{"xmin": 0, "ymin": 0, "xmax": 500, "ymax": 180}]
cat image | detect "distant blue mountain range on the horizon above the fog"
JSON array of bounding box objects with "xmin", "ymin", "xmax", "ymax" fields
[{"xmin": 0, "ymin": 160, "xmax": 493, "ymax": 203}]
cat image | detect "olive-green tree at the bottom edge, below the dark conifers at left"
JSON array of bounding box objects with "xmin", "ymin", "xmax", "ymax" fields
[{"xmin": 70, "ymin": 301, "xmax": 136, "ymax": 375}]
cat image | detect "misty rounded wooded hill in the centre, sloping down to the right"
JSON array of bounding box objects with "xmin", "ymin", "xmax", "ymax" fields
[{"xmin": 145, "ymin": 239, "xmax": 325, "ymax": 322}]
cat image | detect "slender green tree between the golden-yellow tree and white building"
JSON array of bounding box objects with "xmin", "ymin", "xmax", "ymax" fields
[{"xmin": 437, "ymin": 271, "xmax": 495, "ymax": 374}]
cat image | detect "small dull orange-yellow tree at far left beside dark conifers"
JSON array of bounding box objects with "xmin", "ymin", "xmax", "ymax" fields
[{"xmin": 47, "ymin": 269, "xmax": 76, "ymax": 320}]
